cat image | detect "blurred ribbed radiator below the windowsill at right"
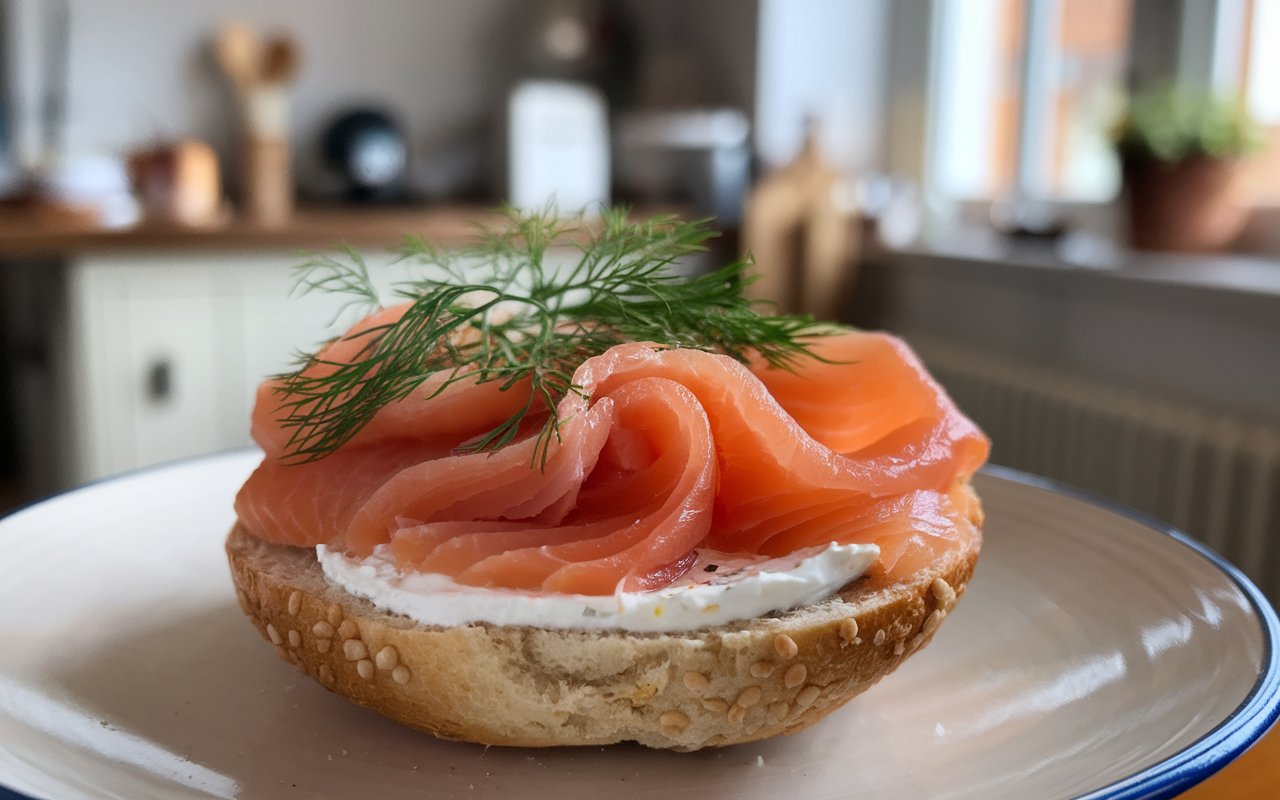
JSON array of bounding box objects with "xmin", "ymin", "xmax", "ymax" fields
[{"xmin": 913, "ymin": 332, "xmax": 1280, "ymax": 603}]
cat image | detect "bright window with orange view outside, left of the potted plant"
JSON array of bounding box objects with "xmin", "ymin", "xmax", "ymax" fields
[{"xmin": 929, "ymin": 0, "xmax": 1133, "ymax": 201}]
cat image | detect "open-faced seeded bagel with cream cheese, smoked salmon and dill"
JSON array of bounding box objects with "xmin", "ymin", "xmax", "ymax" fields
[{"xmin": 227, "ymin": 214, "xmax": 988, "ymax": 750}]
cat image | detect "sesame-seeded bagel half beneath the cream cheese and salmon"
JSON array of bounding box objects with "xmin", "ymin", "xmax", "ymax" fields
[{"xmin": 227, "ymin": 483, "xmax": 982, "ymax": 750}]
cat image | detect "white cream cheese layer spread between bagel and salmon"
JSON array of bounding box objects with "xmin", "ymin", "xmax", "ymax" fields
[{"xmin": 316, "ymin": 543, "xmax": 879, "ymax": 632}]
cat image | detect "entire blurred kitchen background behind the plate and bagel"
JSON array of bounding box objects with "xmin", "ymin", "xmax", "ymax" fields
[{"xmin": 0, "ymin": 0, "xmax": 1280, "ymax": 598}]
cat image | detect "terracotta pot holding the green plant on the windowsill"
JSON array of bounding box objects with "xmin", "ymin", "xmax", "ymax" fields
[{"xmin": 1124, "ymin": 156, "xmax": 1248, "ymax": 252}]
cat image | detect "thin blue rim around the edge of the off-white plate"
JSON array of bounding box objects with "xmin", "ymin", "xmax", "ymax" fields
[{"xmin": 0, "ymin": 451, "xmax": 1280, "ymax": 800}]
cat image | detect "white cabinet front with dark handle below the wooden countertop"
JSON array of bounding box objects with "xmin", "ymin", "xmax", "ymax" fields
[{"xmin": 63, "ymin": 252, "xmax": 389, "ymax": 483}]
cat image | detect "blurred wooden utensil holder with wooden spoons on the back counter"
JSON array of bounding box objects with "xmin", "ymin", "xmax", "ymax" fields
[{"xmin": 216, "ymin": 24, "xmax": 301, "ymax": 227}]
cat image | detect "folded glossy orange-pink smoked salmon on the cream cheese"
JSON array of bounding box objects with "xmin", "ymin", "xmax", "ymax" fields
[{"xmin": 237, "ymin": 307, "xmax": 988, "ymax": 594}]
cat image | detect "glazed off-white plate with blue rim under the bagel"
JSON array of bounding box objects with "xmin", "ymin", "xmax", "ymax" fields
[{"xmin": 0, "ymin": 453, "xmax": 1280, "ymax": 800}]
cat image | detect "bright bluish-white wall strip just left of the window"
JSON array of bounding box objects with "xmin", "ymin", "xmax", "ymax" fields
[{"xmin": 755, "ymin": 0, "xmax": 890, "ymax": 170}]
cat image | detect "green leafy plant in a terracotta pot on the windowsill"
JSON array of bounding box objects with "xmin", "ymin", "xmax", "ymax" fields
[{"xmin": 1116, "ymin": 88, "xmax": 1262, "ymax": 252}]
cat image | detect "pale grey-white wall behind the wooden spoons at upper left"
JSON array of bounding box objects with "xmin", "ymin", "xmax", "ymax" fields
[{"xmin": 12, "ymin": 0, "xmax": 521, "ymax": 190}]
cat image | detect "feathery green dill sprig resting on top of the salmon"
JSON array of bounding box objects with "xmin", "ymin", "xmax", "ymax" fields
[{"xmin": 276, "ymin": 209, "xmax": 829, "ymax": 462}]
